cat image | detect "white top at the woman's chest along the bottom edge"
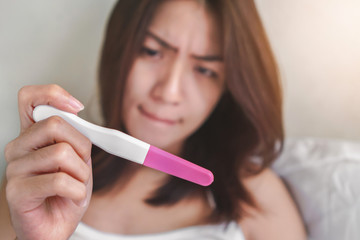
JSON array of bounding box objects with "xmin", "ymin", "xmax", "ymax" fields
[{"xmin": 69, "ymin": 222, "xmax": 245, "ymax": 240}]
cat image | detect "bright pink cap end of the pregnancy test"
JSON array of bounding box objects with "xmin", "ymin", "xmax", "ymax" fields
[{"xmin": 143, "ymin": 146, "xmax": 214, "ymax": 186}]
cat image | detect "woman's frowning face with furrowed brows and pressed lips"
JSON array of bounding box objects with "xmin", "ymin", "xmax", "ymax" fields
[{"xmin": 123, "ymin": 1, "xmax": 224, "ymax": 153}]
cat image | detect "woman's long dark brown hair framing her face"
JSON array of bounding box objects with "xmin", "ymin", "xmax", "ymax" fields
[{"xmin": 93, "ymin": 0, "xmax": 284, "ymax": 221}]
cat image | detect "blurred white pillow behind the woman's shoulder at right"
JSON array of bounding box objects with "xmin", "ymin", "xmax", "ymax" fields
[{"xmin": 273, "ymin": 138, "xmax": 360, "ymax": 240}]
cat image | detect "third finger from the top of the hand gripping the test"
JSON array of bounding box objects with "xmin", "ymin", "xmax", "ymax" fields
[{"xmin": 6, "ymin": 143, "xmax": 91, "ymax": 183}]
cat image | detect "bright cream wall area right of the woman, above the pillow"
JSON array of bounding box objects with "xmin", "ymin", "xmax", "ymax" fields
[{"xmin": 257, "ymin": 0, "xmax": 360, "ymax": 140}]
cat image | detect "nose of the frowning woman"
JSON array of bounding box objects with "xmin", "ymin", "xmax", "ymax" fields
[{"xmin": 152, "ymin": 57, "xmax": 185, "ymax": 105}]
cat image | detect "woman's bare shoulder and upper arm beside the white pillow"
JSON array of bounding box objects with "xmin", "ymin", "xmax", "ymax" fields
[{"xmin": 239, "ymin": 169, "xmax": 306, "ymax": 240}]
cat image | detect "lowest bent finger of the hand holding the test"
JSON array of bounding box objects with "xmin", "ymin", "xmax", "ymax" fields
[{"xmin": 6, "ymin": 172, "xmax": 87, "ymax": 212}]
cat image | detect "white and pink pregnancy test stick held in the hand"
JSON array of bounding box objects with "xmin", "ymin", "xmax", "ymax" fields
[{"xmin": 33, "ymin": 105, "xmax": 214, "ymax": 186}]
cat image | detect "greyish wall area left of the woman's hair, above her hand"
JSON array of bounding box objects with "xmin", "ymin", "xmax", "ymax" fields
[{"xmin": 0, "ymin": 0, "xmax": 115, "ymax": 175}]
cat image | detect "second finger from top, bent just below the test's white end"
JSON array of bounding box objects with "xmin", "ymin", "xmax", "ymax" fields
[{"xmin": 5, "ymin": 116, "xmax": 92, "ymax": 162}]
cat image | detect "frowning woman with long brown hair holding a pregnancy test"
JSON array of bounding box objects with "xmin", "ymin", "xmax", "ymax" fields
[{"xmin": 5, "ymin": 0, "xmax": 305, "ymax": 239}]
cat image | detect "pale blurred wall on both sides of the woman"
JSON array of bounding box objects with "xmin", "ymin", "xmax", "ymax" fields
[{"xmin": 0, "ymin": 0, "xmax": 360, "ymax": 176}]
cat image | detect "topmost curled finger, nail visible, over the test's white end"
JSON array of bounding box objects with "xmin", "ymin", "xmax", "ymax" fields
[{"xmin": 18, "ymin": 84, "xmax": 84, "ymax": 132}]
